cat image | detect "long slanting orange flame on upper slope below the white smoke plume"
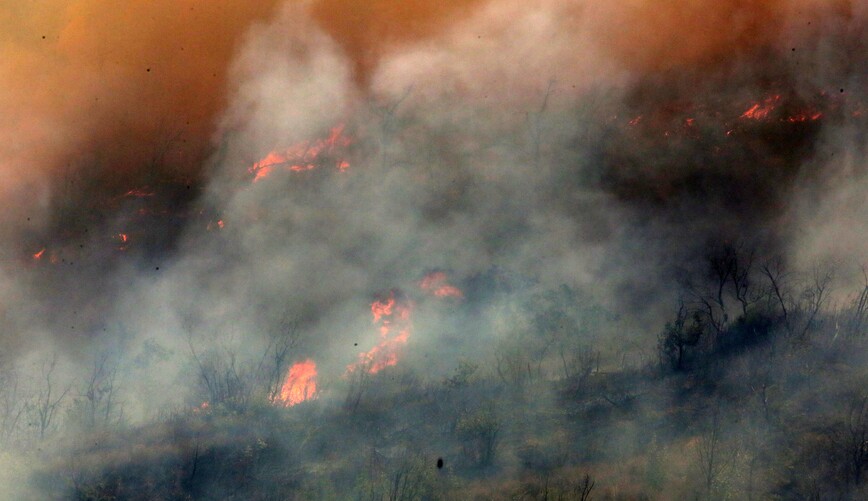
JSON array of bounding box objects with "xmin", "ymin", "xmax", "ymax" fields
[{"xmin": 248, "ymin": 124, "xmax": 352, "ymax": 182}]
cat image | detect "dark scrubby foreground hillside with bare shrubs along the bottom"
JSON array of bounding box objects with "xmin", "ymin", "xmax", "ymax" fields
[{"xmin": 0, "ymin": 244, "xmax": 868, "ymax": 500}]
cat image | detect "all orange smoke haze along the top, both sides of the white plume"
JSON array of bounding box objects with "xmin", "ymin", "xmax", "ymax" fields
[{"xmin": 0, "ymin": 0, "xmax": 855, "ymax": 201}]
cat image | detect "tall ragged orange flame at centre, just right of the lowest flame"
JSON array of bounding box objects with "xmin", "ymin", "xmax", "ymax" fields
[{"xmin": 347, "ymin": 293, "xmax": 411, "ymax": 374}]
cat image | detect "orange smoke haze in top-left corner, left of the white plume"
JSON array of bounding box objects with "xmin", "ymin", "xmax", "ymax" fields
[{"xmin": 0, "ymin": 0, "xmax": 277, "ymax": 192}]
